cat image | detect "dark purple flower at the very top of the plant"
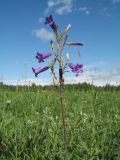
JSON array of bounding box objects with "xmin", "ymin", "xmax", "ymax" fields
[{"xmin": 45, "ymin": 15, "xmax": 57, "ymax": 34}]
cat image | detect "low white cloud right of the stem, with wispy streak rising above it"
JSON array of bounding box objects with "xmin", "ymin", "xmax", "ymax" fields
[{"xmin": 65, "ymin": 61, "xmax": 120, "ymax": 86}]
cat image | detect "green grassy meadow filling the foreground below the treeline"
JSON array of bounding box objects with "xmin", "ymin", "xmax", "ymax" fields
[{"xmin": 0, "ymin": 84, "xmax": 120, "ymax": 160}]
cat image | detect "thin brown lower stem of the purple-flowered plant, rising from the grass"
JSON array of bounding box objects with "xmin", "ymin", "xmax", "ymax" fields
[{"xmin": 59, "ymin": 68, "xmax": 67, "ymax": 148}]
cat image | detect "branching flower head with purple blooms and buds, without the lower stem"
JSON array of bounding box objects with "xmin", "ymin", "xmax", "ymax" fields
[{"xmin": 32, "ymin": 15, "xmax": 83, "ymax": 81}]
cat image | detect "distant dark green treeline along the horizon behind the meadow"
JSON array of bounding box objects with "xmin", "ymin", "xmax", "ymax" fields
[{"xmin": 0, "ymin": 82, "xmax": 120, "ymax": 91}]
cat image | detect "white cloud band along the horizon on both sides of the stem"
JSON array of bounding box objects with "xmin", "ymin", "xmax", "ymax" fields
[{"xmin": 3, "ymin": 71, "xmax": 120, "ymax": 86}]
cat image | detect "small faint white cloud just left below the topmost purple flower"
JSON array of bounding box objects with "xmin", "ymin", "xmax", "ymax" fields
[{"xmin": 32, "ymin": 28, "xmax": 54, "ymax": 42}]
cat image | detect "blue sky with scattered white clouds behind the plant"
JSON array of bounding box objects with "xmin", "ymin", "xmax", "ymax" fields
[{"xmin": 0, "ymin": 0, "xmax": 120, "ymax": 84}]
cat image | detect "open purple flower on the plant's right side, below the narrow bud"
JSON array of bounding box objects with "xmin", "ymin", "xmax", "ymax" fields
[{"xmin": 68, "ymin": 63, "xmax": 83, "ymax": 76}]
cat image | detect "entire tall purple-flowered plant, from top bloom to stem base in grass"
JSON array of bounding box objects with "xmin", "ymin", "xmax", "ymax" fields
[{"xmin": 32, "ymin": 15, "xmax": 83, "ymax": 147}]
